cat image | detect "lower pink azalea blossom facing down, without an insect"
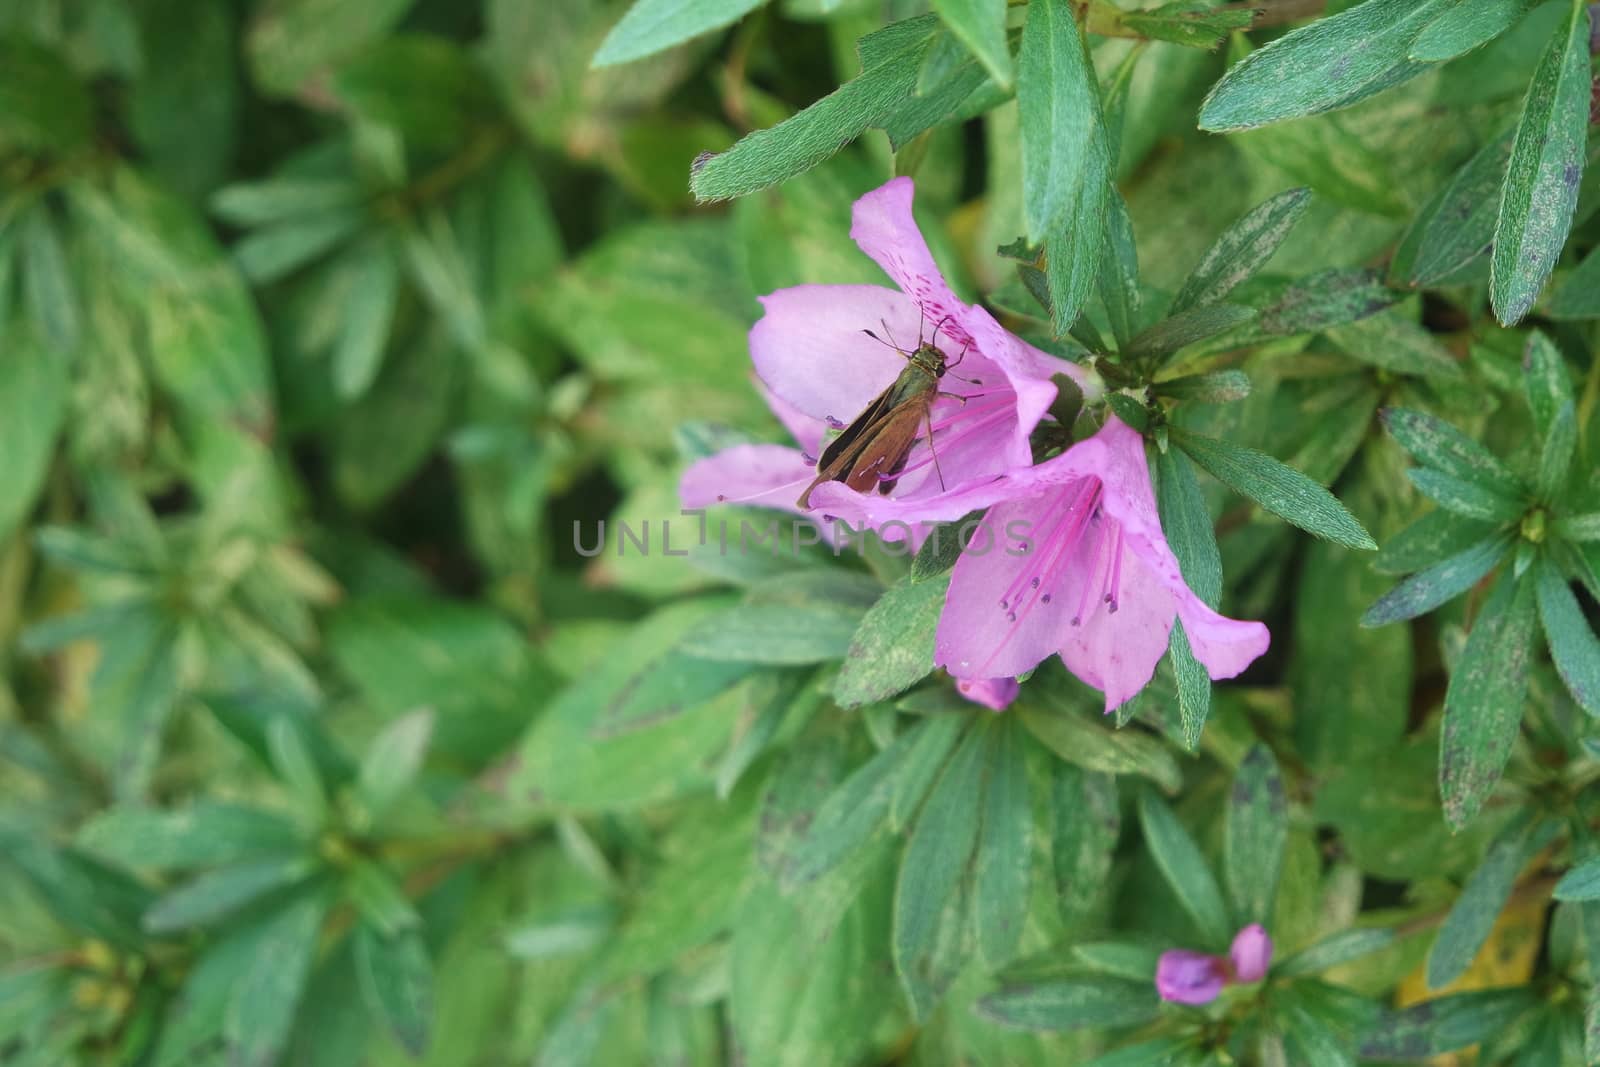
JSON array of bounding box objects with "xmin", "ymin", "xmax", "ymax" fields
[{"xmin": 844, "ymin": 416, "xmax": 1270, "ymax": 712}]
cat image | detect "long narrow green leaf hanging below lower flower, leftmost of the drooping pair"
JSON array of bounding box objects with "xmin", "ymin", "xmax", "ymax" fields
[{"xmin": 893, "ymin": 729, "xmax": 987, "ymax": 1019}]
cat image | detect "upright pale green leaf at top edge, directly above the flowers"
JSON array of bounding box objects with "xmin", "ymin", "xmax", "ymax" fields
[{"xmin": 1018, "ymin": 0, "xmax": 1109, "ymax": 241}]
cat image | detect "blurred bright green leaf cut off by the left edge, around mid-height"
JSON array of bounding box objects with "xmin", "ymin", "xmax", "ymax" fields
[{"xmin": 0, "ymin": 328, "xmax": 67, "ymax": 541}]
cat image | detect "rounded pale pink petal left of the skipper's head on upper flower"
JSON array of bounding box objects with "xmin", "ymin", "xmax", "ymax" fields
[{"xmin": 750, "ymin": 285, "xmax": 920, "ymax": 422}]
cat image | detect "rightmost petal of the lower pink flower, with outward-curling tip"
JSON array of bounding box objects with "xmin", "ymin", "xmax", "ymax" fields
[{"xmin": 1069, "ymin": 418, "xmax": 1270, "ymax": 699}]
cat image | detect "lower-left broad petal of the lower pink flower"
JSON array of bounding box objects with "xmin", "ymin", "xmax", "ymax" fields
[{"xmin": 933, "ymin": 496, "xmax": 1070, "ymax": 680}]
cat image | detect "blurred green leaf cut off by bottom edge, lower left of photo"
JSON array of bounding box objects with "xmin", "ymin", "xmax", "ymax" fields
[{"xmin": 222, "ymin": 893, "xmax": 328, "ymax": 1067}]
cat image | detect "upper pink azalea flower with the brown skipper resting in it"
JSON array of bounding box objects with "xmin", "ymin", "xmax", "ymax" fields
[{"xmin": 680, "ymin": 178, "xmax": 1086, "ymax": 542}]
